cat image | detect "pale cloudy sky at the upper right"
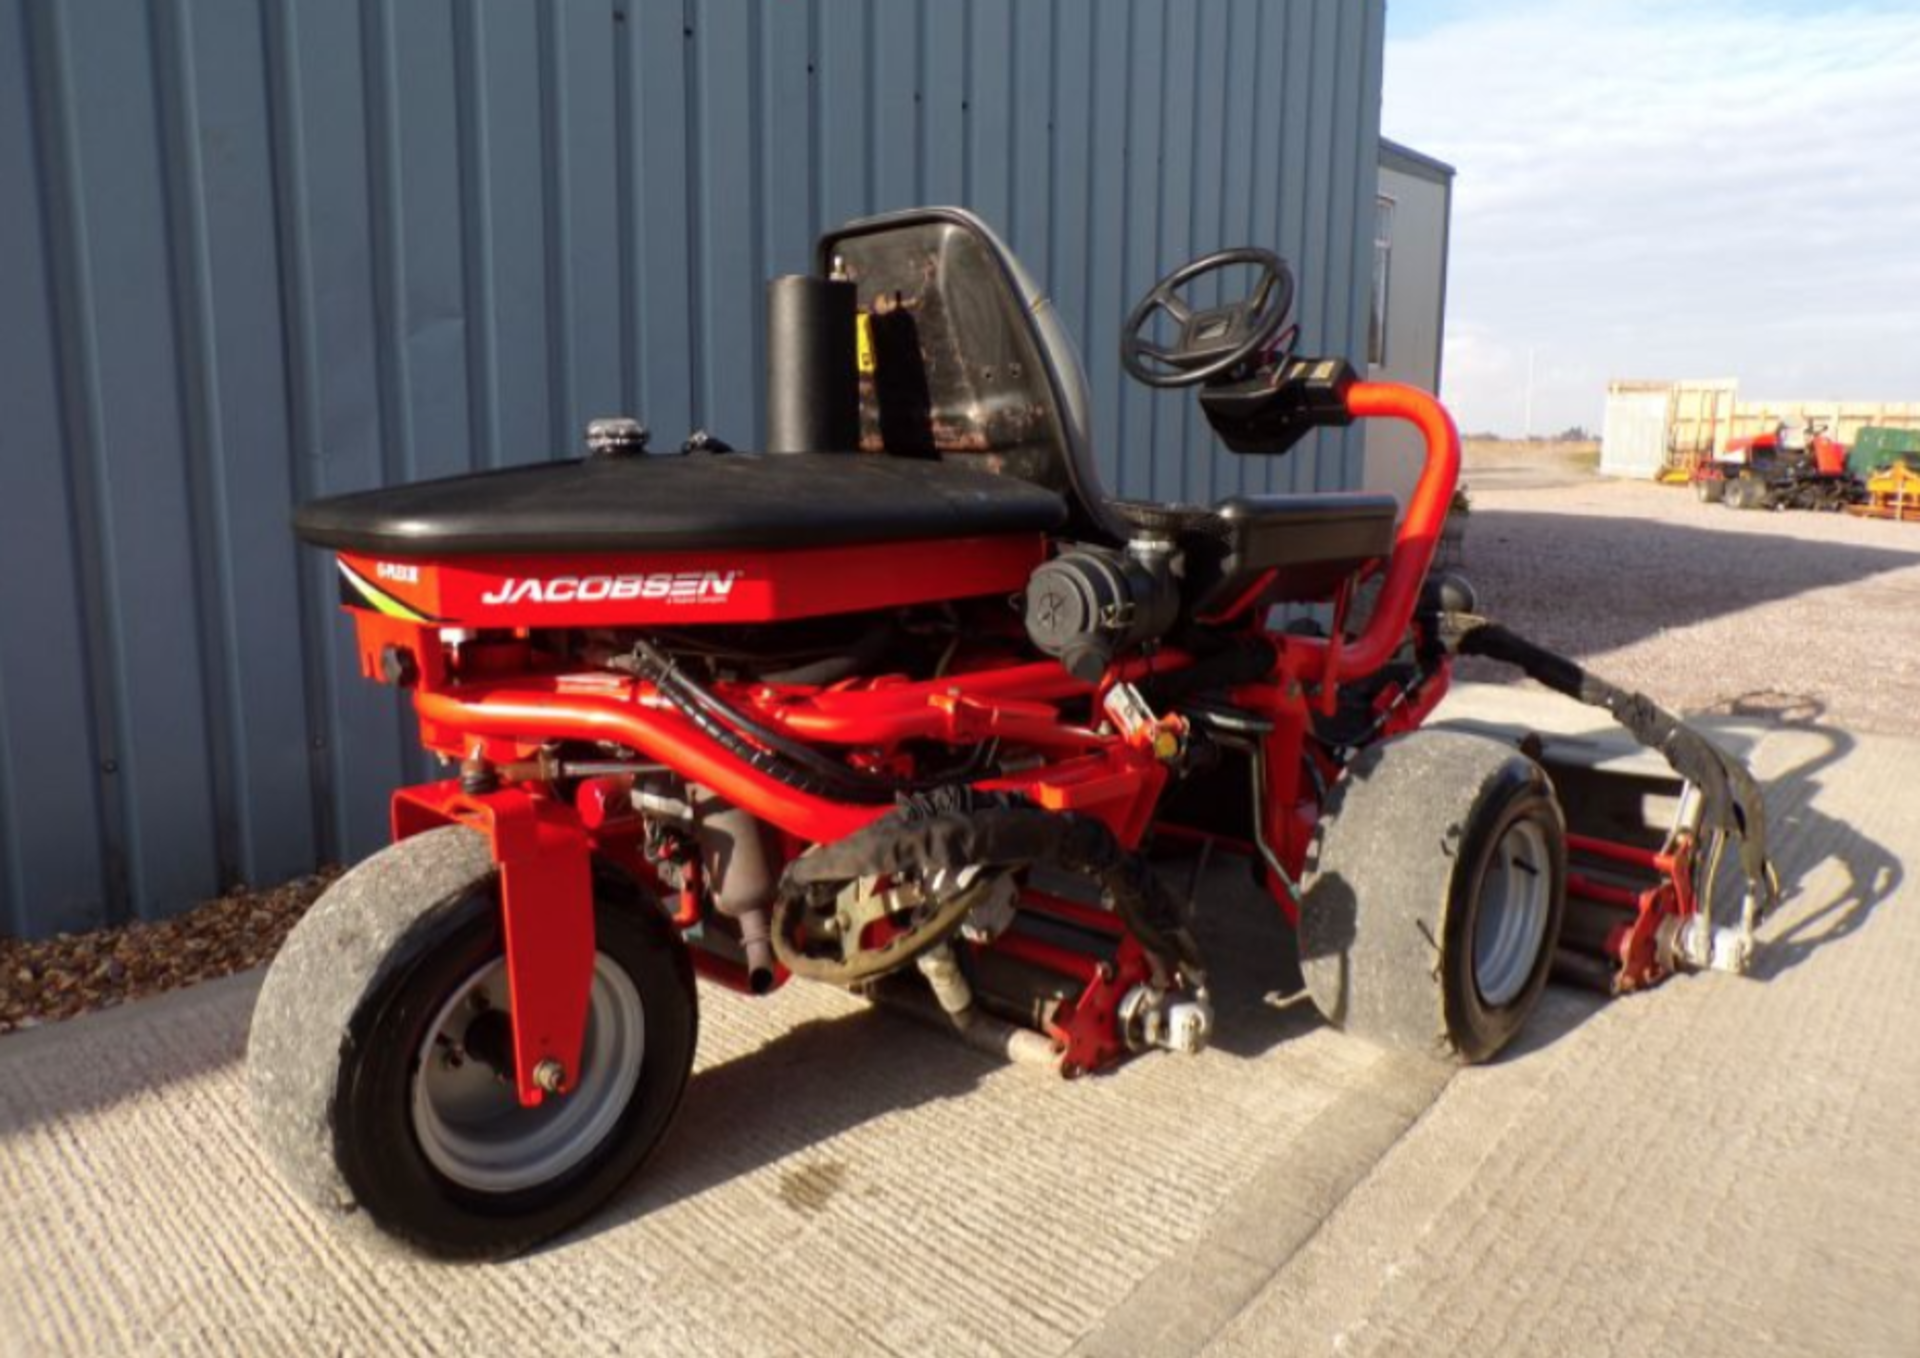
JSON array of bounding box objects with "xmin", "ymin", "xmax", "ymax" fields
[{"xmin": 1380, "ymin": 0, "xmax": 1920, "ymax": 434}]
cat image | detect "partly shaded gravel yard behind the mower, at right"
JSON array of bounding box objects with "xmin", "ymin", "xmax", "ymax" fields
[{"xmin": 1461, "ymin": 446, "xmax": 1920, "ymax": 736}]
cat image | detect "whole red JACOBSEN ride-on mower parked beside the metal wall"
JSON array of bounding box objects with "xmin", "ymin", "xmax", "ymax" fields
[{"xmin": 248, "ymin": 211, "xmax": 1770, "ymax": 1256}]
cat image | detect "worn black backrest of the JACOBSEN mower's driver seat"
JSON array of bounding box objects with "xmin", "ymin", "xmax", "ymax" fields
[{"xmin": 818, "ymin": 207, "xmax": 1127, "ymax": 542}]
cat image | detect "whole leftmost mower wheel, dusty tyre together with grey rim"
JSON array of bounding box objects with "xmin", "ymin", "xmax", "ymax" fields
[{"xmin": 248, "ymin": 828, "xmax": 699, "ymax": 1258}]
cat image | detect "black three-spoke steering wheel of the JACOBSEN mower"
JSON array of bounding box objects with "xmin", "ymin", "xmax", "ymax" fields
[{"xmin": 1119, "ymin": 246, "xmax": 1294, "ymax": 388}]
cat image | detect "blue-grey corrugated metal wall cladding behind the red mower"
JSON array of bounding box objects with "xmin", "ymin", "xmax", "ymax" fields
[{"xmin": 0, "ymin": 0, "xmax": 1384, "ymax": 934}]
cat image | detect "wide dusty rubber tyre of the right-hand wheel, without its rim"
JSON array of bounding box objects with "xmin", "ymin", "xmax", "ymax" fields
[{"xmin": 1300, "ymin": 732, "xmax": 1567, "ymax": 1064}]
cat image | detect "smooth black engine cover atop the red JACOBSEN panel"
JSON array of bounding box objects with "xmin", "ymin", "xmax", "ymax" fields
[{"xmin": 294, "ymin": 453, "xmax": 1068, "ymax": 557}]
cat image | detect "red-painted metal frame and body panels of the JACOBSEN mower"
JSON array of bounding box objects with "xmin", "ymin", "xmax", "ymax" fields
[{"xmin": 342, "ymin": 382, "xmax": 1489, "ymax": 1104}]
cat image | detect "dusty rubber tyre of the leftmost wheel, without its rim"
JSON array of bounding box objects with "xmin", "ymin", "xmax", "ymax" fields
[{"xmin": 248, "ymin": 828, "xmax": 699, "ymax": 1258}]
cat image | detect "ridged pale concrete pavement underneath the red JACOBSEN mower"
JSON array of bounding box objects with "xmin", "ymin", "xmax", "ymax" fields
[{"xmin": 0, "ymin": 690, "xmax": 1920, "ymax": 1354}]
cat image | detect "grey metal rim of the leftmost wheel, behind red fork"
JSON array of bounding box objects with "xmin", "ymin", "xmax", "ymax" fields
[{"xmin": 413, "ymin": 953, "xmax": 647, "ymax": 1193}]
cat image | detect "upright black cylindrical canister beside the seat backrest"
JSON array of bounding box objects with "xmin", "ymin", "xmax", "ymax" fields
[{"xmin": 766, "ymin": 273, "xmax": 860, "ymax": 453}]
